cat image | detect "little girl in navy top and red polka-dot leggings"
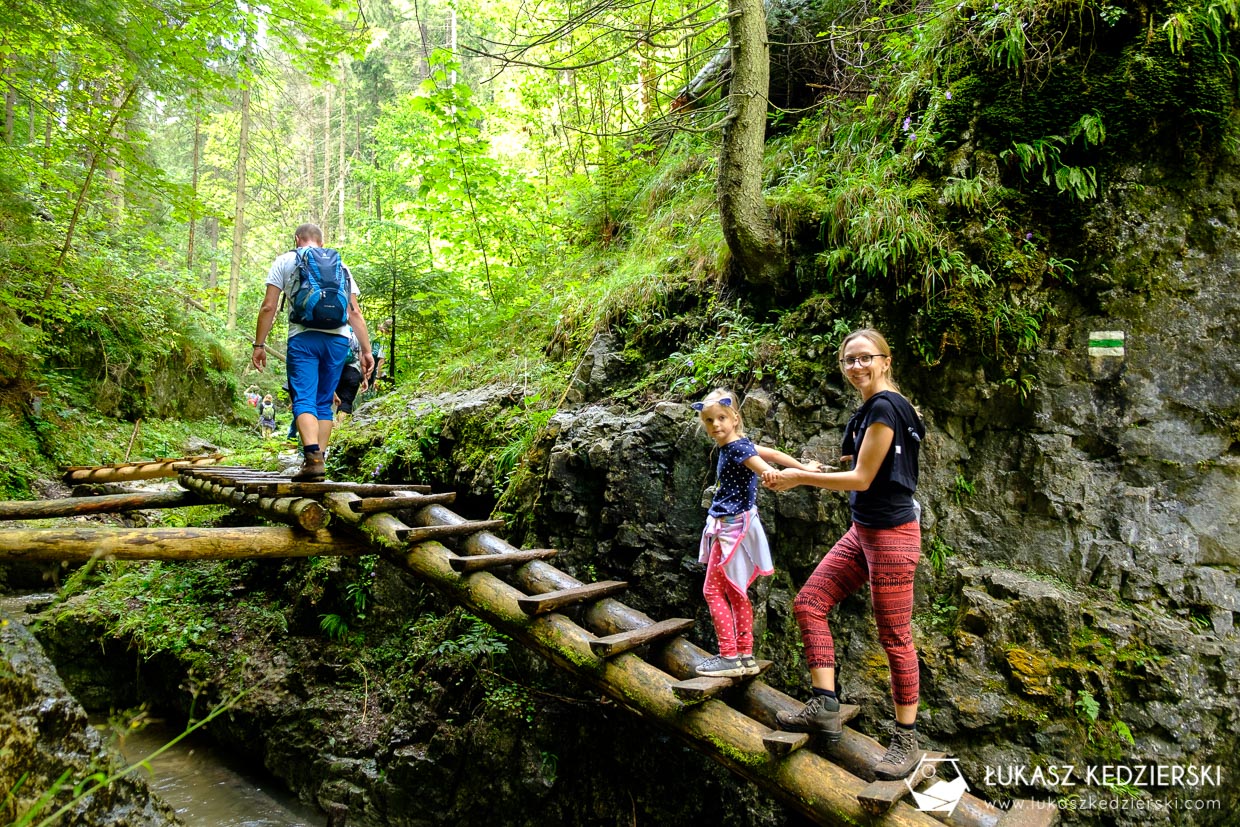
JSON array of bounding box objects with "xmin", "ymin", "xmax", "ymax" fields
[{"xmin": 693, "ymin": 388, "xmax": 821, "ymax": 677}]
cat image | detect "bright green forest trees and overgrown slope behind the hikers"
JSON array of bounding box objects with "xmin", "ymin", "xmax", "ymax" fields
[{"xmin": 0, "ymin": 0, "xmax": 1236, "ymax": 417}]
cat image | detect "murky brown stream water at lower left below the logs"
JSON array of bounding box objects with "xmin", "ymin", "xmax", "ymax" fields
[{"xmin": 0, "ymin": 594, "xmax": 327, "ymax": 827}]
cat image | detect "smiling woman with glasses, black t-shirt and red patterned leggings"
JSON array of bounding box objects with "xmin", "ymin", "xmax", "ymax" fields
[{"xmin": 763, "ymin": 329, "xmax": 925, "ymax": 780}]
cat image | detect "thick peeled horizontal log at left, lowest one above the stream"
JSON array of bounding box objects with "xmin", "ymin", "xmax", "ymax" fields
[{"xmin": 0, "ymin": 526, "xmax": 373, "ymax": 563}]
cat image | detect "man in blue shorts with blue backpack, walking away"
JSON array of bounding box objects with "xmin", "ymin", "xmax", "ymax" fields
[{"xmin": 250, "ymin": 224, "xmax": 374, "ymax": 482}]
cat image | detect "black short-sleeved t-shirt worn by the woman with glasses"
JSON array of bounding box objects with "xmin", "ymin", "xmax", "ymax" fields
[{"xmin": 839, "ymin": 391, "xmax": 926, "ymax": 528}]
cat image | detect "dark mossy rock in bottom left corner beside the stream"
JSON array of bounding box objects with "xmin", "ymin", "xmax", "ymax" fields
[{"xmin": 0, "ymin": 614, "xmax": 182, "ymax": 827}]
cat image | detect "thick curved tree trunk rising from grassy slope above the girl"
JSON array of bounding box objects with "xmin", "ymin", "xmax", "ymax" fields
[{"xmin": 717, "ymin": 0, "xmax": 787, "ymax": 286}]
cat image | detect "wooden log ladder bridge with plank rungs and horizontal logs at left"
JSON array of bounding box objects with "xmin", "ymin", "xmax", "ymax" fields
[{"xmin": 0, "ymin": 458, "xmax": 1059, "ymax": 827}]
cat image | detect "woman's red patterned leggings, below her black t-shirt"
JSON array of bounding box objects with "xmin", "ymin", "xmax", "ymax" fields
[{"xmin": 792, "ymin": 522, "xmax": 921, "ymax": 705}]
